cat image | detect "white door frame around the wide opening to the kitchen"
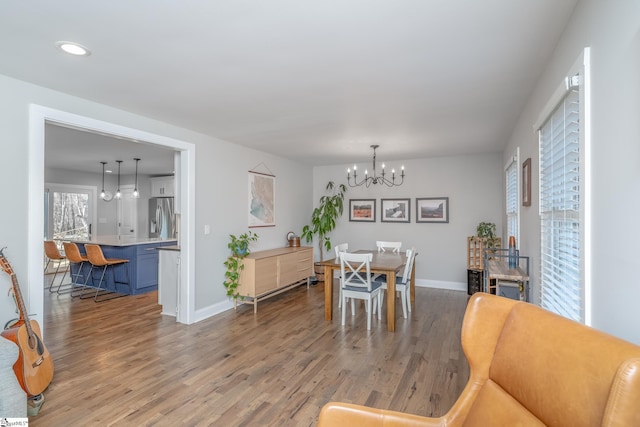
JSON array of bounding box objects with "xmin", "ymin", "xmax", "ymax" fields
[{"xmin": 27, "ymin": 104, "xmax": 196, "ymax": 329}]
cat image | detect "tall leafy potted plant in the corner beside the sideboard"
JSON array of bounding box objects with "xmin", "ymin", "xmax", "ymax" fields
[{"xmin": 301, "ymin": 181, "xmax": 347, "ymax": 281}]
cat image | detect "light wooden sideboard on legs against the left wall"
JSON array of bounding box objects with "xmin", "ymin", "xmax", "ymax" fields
[{"xmin": 234, "ymin": 246, "xmax": 313, "ymax": 313}]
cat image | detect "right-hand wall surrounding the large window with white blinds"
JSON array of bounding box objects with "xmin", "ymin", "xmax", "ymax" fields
[{"xmin": 505, "ymin": 0, "xmax": 640, "ymax": 344}]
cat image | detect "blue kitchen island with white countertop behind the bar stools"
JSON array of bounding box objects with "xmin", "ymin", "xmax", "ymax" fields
[{"xmin": 71, "ymin": 236, "xmax": 177, "ymax": 295}]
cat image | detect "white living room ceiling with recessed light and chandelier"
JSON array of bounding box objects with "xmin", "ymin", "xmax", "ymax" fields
[{"xmin": 0, "ymin": 0, "xmax": 577, "ymax": 172}]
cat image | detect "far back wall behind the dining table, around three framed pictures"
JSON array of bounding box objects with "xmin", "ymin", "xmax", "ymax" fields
[{"xmin": 313, "ymin": 154, "xmax": 504, "ymax": 290}]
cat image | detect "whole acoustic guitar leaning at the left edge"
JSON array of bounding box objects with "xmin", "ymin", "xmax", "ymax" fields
[{"xmin": 0, "ymin": 248, "xmax": 53, "ymax": 397}]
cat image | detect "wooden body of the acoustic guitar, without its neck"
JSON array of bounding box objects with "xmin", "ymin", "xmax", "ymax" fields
[{"xmin": 2, "ymin": 320, "xmax": 53, "ymax": 396}]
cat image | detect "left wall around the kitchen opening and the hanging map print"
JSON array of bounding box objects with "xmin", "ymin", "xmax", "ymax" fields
[{"xmin": 0, "ymin": 76, "xmax": 312, "ymax": 324}]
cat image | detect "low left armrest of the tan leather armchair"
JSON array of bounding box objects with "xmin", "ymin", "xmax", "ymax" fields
[{"xmin": 318, "ymin": 402, "xmax": 445, "ymax": 427}]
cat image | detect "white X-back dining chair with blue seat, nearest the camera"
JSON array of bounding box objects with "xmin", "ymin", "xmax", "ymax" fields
[{"xmin": 340, "ymin": 252, "xmax": 382, "ymax": 331}]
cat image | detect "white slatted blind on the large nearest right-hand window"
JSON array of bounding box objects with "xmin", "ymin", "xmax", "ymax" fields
[{"xmin": 539, "ymin": 80, "xmax": 584, "ymax": 322}]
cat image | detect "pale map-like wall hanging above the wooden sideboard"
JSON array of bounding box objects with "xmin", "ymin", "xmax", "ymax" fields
[{"xmin": 248, "ymin": 171, "xmax": 276, "ymax": 228}]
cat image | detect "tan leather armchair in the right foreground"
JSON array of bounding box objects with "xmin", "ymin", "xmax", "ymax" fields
[{"xmin": 318, "ymin": 293, "xmax": 640, "ymax": 427}]
